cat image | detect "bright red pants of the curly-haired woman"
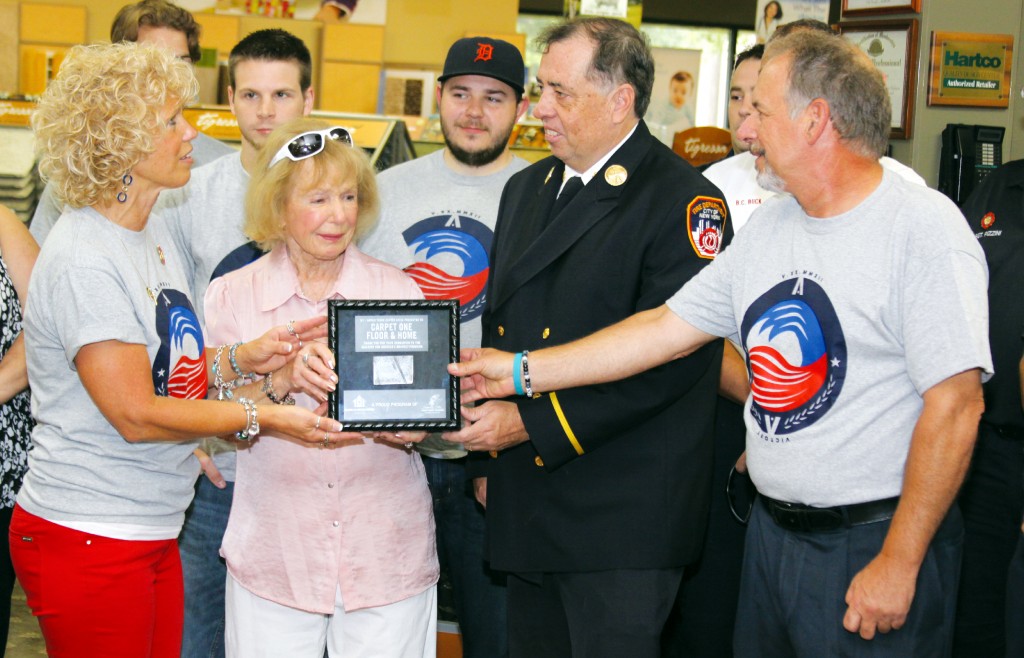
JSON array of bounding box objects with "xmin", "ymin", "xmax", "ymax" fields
[{"xmin": 10, "ymin": 506, "xmax": 184, "ymax": 658}]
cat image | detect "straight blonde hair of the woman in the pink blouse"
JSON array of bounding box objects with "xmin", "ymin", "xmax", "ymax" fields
[{"xmin": 245, "ymin": 117, "xmax": 380, "ymax": 251}]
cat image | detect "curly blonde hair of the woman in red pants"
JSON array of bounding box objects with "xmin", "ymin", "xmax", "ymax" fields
[{"xmin": 32, "ymin": 43, "xmax": 199, "ymax": 208}]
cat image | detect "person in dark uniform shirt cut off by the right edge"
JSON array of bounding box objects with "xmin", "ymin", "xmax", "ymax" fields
[{"xmin": 953, "ymin": 160, "xmax": 1024, "ymax": 658}]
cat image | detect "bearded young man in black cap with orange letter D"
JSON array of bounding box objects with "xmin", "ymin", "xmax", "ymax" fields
[{"xmin": 359, "ymin": 37, "xmax": 529, "ymax": 658}]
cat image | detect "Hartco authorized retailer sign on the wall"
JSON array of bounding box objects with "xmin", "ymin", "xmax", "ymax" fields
[{"xmin": 928, "ymin": 32, "xmax": 1014, "ymax": 107}]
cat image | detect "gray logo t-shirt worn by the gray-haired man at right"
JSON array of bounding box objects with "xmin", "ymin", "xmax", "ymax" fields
[{"xmin": 668, "ymin": 172, "xmax": 992, "ymax": 507}]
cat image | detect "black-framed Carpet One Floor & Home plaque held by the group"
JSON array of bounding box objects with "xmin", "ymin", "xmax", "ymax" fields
[{"xmin": 327, "ymin": 300, "xmax": 462, "ymax": 432}]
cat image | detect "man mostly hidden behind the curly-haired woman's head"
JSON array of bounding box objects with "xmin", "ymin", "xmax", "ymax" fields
[{"xmin": 29, "ymin": 0, "xmax": 234, "ymax": 245}]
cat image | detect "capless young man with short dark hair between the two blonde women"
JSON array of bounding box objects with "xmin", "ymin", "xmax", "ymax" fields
[{"xmin": 154, "ymin": 30, "xmax": 313, "ymax": 657}]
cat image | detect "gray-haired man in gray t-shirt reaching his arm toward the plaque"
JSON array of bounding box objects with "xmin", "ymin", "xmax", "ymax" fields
[{"xmin": 452, "ymin": 31, "xmax": 992, "ymax": 656}]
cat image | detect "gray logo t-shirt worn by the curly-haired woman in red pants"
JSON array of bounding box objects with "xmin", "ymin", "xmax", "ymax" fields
[{"xmin": 18, "ymin": 208, "xmax": 201, "ymax": 537}]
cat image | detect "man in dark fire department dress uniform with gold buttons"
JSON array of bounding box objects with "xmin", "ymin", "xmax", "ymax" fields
[{"xmin": 446, "ymin": 18, "xmax": 731, "ymax": 658}]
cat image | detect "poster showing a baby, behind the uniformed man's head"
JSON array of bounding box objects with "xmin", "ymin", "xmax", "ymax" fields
[{"xmin": 644, "ymin": 48, "xmax": 700, "ymax": 147}]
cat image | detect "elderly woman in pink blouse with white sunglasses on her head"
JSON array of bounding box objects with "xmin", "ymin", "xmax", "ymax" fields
[{"xmin": 206, "ymin": 119, "xmax": 438, "ymax": 658}]
